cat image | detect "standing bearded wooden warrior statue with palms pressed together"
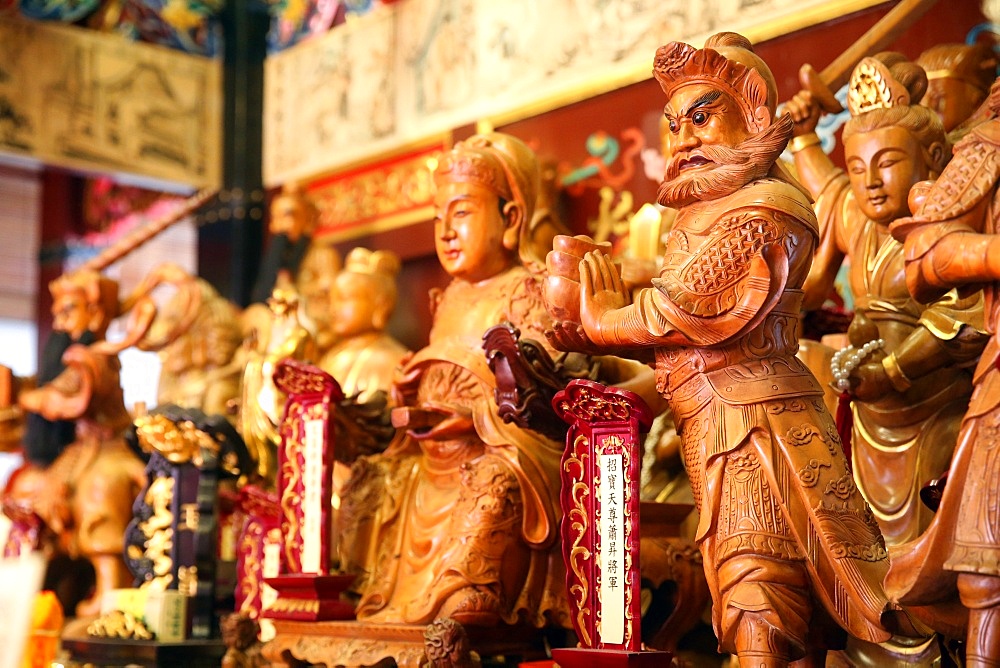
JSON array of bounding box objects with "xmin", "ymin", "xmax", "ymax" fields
[{"xmin": 546, "ymin": 33, "xmax": 894, "ymax": 666}]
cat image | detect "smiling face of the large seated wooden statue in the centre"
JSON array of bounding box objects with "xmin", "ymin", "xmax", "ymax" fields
[{"xmin": 434, "ymin": 182, "xmax": 516, "ymax": 283}]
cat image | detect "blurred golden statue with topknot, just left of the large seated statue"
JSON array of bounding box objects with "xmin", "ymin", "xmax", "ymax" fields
[{"xmin": 319, "ymin": 248, "xmax": 408, "ymax": 403}]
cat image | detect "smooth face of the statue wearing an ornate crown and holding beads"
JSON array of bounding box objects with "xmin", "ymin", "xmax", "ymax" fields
[{"xmin": 844, "ymin": 126, "xmax": 930, "ymax": 225}]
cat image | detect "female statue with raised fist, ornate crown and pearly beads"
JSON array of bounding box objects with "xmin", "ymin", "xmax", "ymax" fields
[{"xmin": 786, "ymin": 54, "xmax": 984, "ymax": 548}]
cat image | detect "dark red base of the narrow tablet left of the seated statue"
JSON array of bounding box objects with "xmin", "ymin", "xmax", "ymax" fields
[{"xmin": 261, "ymin": 575, "xmax": 354, "ymax": 622}]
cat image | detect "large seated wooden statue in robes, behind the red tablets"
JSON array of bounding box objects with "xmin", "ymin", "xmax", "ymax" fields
[{"xmin": 341, "ymin": 134, "xmax": 580, "ymax": 626}]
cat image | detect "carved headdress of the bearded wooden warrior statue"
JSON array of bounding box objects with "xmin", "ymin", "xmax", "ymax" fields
[{"xmin": 653, "ymin": 32, "xmax": 778, "ymax": 132}]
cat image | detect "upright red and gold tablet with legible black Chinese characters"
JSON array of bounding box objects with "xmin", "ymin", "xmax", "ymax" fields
[{"xmin": 553, "ymin": 380, "xmax": 670, "ymax": 667}]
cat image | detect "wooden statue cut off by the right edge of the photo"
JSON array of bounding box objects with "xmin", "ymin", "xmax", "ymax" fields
[{"xmin": 885, "ymin": 79, "xmax": 1000, "ymax": 668}]
